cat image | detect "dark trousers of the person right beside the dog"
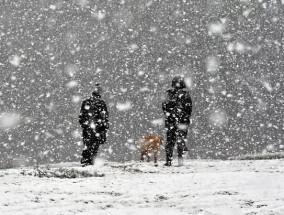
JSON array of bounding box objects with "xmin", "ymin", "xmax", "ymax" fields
[{"xmin": 165, "ymin": 126, "xmax": 188, "ymax": 162}]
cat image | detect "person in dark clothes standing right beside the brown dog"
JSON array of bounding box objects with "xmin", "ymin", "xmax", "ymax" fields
[{"xmin": 162, "ymin": 76, "xmax": 192, "ymax": 166}]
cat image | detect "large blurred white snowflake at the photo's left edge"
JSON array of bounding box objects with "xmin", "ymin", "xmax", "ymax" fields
[{"xmin": 0, "ymin": 112, "xmax": 21, "ymax": 130}]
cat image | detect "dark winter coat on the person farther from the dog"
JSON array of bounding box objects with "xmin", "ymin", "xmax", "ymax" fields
[{"xmin": 79, "ymin": 95, "xmax": 109, "ymax": 133}]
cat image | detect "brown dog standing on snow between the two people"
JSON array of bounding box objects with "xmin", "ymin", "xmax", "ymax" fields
[{"xmin": 140, "ymin": 134, "xmax": 163, "ymax": 165}]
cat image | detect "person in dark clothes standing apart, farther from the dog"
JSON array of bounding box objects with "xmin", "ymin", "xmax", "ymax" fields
[{"xmin": 79, "ymin": 84, "xmax": 109, "ymax": 166}]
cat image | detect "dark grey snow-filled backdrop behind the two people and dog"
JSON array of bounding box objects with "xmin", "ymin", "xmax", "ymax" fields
[{"xmin": 0, "ymin": 0, "xmax": 284, "ymax": 167}]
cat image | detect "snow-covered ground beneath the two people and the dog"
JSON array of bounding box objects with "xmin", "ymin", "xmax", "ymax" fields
[{"xmin": 0, "ymin": 159, "xmax": 284, "ymax": 215}]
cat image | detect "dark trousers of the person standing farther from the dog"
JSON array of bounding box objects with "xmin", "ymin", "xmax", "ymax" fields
[{"xmin": 81, "ymin": 128, "xmax": 106, "ymax": 165}]
